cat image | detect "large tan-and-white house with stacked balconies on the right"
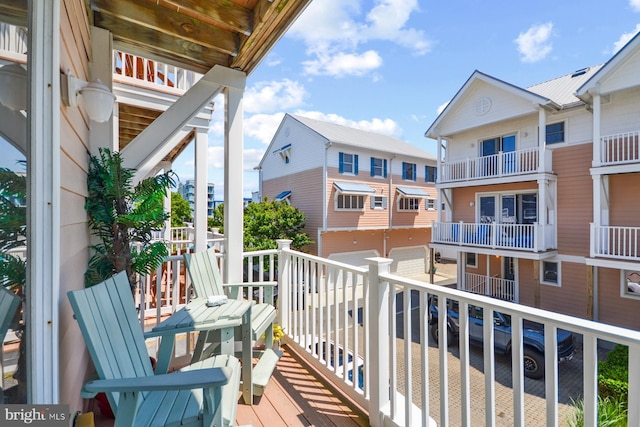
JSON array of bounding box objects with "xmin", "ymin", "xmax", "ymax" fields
[{"xmin": 426, "ymin": 32, "xmax": 640, "ymax": 329}]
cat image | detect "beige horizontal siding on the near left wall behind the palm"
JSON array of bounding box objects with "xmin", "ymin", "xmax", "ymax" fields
[{"xmin": 59, "ymin": 0, "xmax": 92, "ymax": 413}]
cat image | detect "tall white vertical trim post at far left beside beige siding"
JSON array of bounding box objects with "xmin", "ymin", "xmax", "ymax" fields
[{"xmin": 24, "ymin": 0, "xmax": 60, "ymax": 404}]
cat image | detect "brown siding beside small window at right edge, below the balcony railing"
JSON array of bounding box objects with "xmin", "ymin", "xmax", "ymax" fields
[{"xmin": 598, "ymin": 268, "xmax": 640, "ymax": 329}]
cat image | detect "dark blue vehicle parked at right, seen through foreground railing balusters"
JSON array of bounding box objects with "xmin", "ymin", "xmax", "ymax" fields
[{"xmin": 429, "ymin": 296, "xmax": 575, "ymax": 379}]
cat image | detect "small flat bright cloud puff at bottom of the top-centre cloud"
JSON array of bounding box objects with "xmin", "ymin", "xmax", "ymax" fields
[{"xmin": 303, "ymin": 50, "xmax": 382, "ymax": 77}]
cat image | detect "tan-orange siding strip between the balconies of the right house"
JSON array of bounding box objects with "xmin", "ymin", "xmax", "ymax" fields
[{"xmin": 553, "ymin": 144, "xmax": 593, "ymax": 256}]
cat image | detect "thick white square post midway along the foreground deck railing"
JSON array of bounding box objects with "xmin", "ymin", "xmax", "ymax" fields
[{"xmin": 367, "ymin": 257, "xmax": 393, "ymax": 427}]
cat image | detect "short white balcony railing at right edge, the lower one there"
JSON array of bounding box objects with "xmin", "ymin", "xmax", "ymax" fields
[{"xmin": 591, "ymin": 223, "xmax": 640, "ymax": 261}]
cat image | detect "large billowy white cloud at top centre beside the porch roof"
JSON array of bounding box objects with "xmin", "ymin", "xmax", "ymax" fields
[{"xmin": 287, "ymin": 0, "xmax": 431, "ymax": 76}]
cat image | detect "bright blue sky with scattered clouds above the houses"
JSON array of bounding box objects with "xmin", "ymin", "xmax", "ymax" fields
[{"xmin": 0, "ymin": 0, "xmax": 640, "ymax": 199}]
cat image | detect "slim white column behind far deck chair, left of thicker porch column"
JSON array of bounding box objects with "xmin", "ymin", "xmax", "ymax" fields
[{"xmin": 193, "ymin": 128, "xmax": 208, "ymax": 252}]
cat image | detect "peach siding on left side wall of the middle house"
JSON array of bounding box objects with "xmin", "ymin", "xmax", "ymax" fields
[{"xmin": 262, "ymin": 168, "xmax": 323, "ymax": 253}]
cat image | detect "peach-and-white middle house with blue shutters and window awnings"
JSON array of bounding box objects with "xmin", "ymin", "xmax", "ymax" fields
[{"xmin": 258, "ymin": 114, "xmax": 436, "ymax": 276}]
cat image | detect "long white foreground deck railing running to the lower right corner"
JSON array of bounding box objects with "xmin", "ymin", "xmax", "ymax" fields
[{"xmin": 134, "ymin": 241, "xmax": 640, "ymax": 426}]
